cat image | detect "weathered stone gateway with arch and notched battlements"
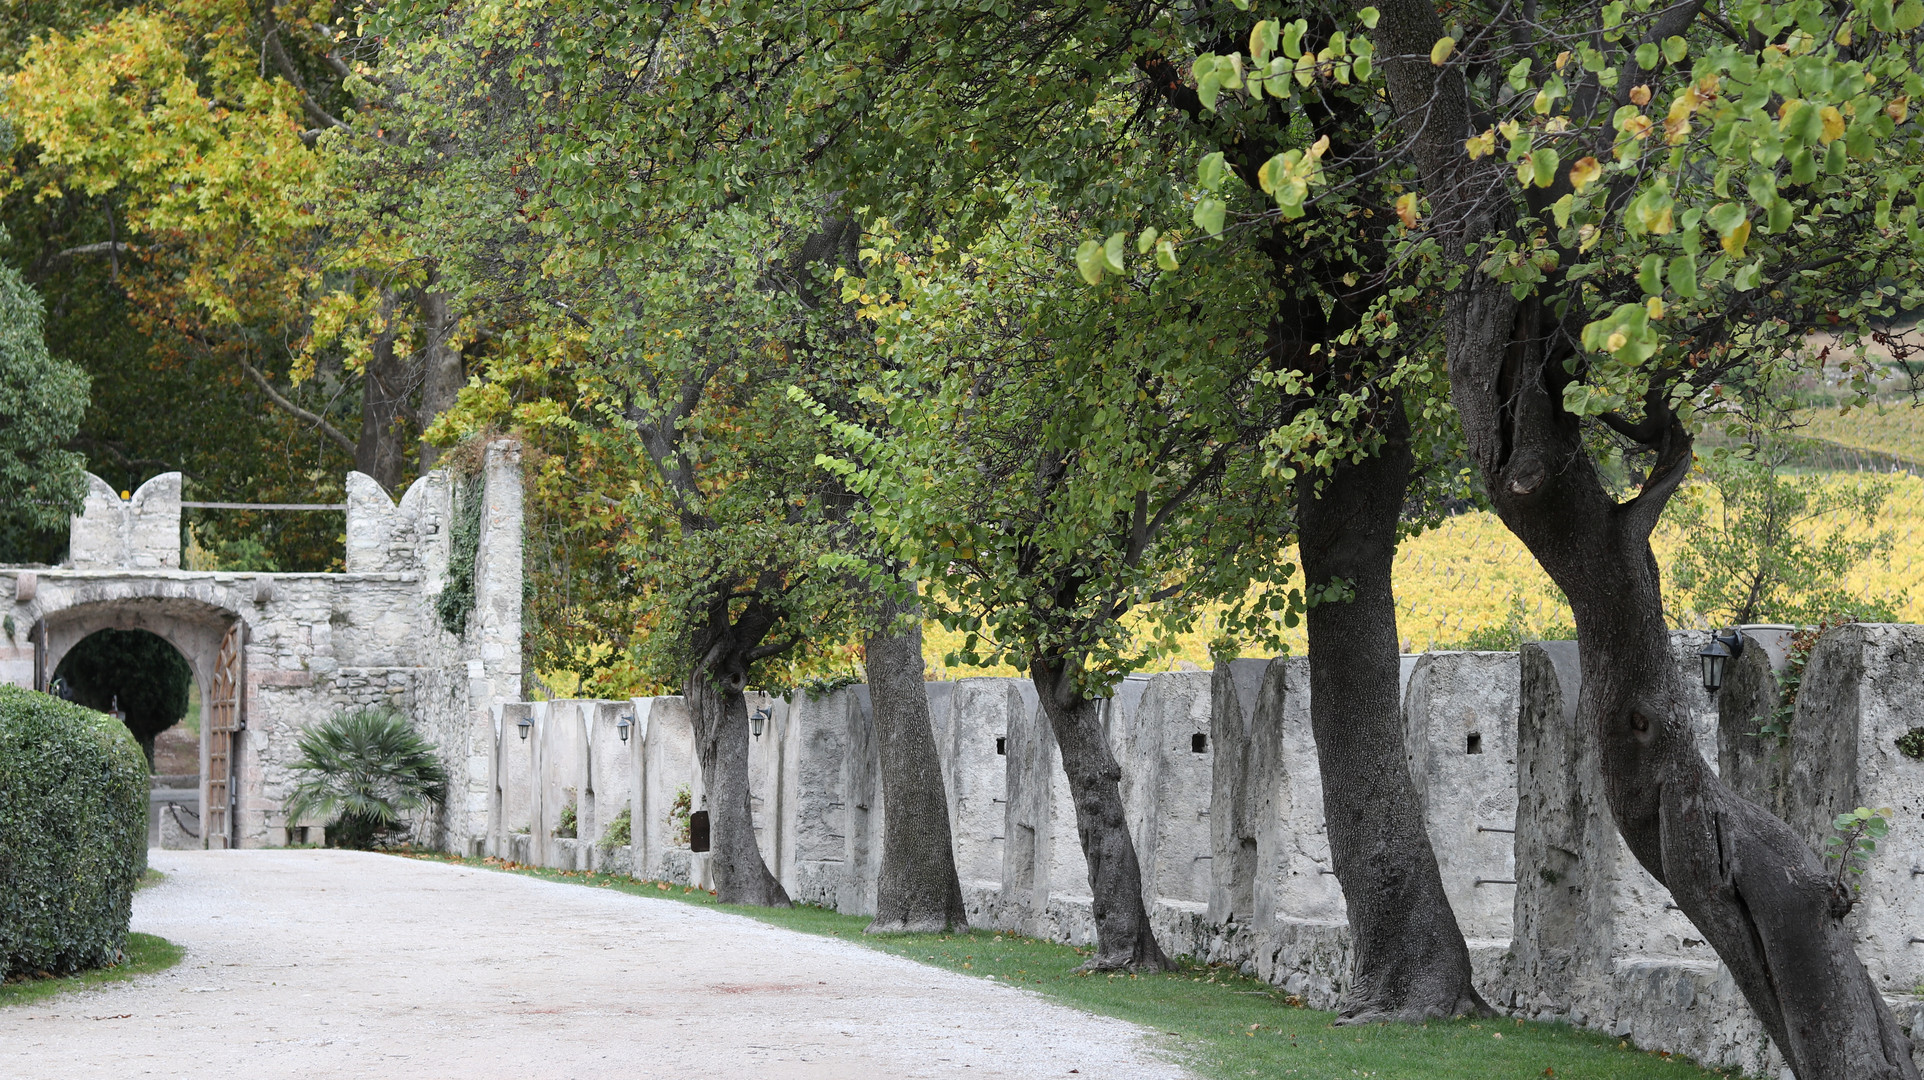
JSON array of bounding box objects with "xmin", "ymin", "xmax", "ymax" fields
[{"xmin": 0, "ymin": 441, "xmax": 521, "ymax": 851}]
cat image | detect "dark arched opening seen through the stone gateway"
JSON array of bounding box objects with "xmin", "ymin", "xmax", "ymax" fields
[{"xmin": 52, "ymin": 630, "xmax": 200, "ymax": 772}]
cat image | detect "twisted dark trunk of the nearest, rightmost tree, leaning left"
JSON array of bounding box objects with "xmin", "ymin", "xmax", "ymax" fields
[{"xmin": 1378, "ymin": 0, "xmax": 1918, "ymax": 1080}]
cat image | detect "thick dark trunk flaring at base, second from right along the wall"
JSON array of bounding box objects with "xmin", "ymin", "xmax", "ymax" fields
[{"xmin": 1297, "ymin": 399, "xmax": 1487, "ymax": 1024}]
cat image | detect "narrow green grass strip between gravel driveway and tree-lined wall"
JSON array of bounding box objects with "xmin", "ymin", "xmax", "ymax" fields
[{"xmin": 394, "ymin": 853, "xmax": 1732, "ymax": 1080}]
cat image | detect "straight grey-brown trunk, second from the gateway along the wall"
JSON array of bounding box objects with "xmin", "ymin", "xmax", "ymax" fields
[{"xmin": 866, "ymin": 585, "xmax": 968, "ymax": 934}]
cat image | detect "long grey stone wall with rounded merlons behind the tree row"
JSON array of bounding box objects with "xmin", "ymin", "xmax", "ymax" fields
[{"xmin": 491, "ymin": 626, "xmax": 1924, "ymax": 1074}]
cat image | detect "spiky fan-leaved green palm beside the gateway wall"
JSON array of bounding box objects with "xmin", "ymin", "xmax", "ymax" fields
[{"xmin": 287, "ymin": 708, "xmax": 448, "ymax": 849}]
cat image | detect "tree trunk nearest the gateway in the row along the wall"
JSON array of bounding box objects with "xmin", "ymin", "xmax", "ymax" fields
[{"xmin": 683, "ymin": 647, "xmax": 789, "ymax": 907}]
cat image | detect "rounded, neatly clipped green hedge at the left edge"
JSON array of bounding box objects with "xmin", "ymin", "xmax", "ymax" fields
[{"xmin": 0, "ymin": 685, "xmax": 148, "ymax": 978}]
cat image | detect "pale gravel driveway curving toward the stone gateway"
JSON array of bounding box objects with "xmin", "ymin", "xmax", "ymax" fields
[{"xmin": 0, "ymin": 851, "xmax": 1185, "ymax": 1080}]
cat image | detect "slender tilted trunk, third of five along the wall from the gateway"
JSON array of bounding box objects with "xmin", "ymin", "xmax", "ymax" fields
[{"xmin": 1029, "ymin": 656, "xmax": 1176, "ymax": 970}]
